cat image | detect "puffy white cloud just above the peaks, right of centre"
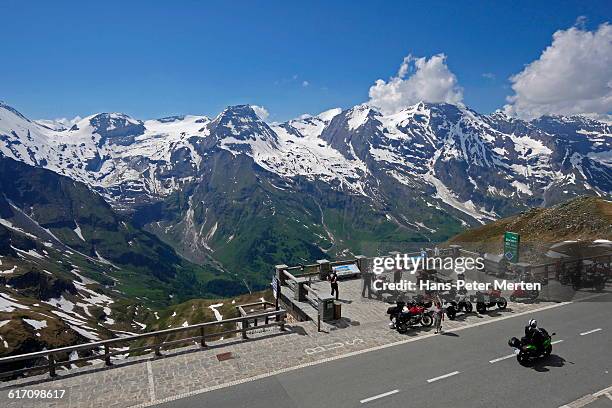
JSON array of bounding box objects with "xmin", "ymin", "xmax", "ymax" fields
[{"xmin": 369, "ymin": 54, "xmax": 463, "ymax": 113}]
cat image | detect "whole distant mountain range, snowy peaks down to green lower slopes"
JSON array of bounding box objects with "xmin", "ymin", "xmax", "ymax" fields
[{"xmin": 0, "ymin": 99, "xmax": 612, "ymax": 286}]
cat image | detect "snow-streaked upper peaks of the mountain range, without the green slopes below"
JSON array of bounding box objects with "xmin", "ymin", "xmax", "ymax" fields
[{"xmin": 0, "ymin": 103, "xmax": 612, "ymax": 215}]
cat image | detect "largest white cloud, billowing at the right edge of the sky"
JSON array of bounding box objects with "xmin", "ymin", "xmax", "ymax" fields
[{"xmin": 504, "ymin": 22, "xmax": 612, "ymax": 119}]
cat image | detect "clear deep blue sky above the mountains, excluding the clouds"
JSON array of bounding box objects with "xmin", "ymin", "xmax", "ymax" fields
[{"xmin": 0, "ymin": 0, "xmax": 612, "ymax": 120}]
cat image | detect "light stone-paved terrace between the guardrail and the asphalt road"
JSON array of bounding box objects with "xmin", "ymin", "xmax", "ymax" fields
[{"xmin": 0, "ymin": 279, "xmax": 604, "ymax": 408}]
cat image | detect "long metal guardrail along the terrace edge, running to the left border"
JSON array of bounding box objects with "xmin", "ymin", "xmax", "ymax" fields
[{"xmin": 0, "ymin": 309, "xmax": 287, "ymax": 378}]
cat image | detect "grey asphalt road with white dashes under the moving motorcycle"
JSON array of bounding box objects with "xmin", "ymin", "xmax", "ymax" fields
[{"xmin": 158, "ymin": 294, "xmax": 612, "ymax": 408}]
